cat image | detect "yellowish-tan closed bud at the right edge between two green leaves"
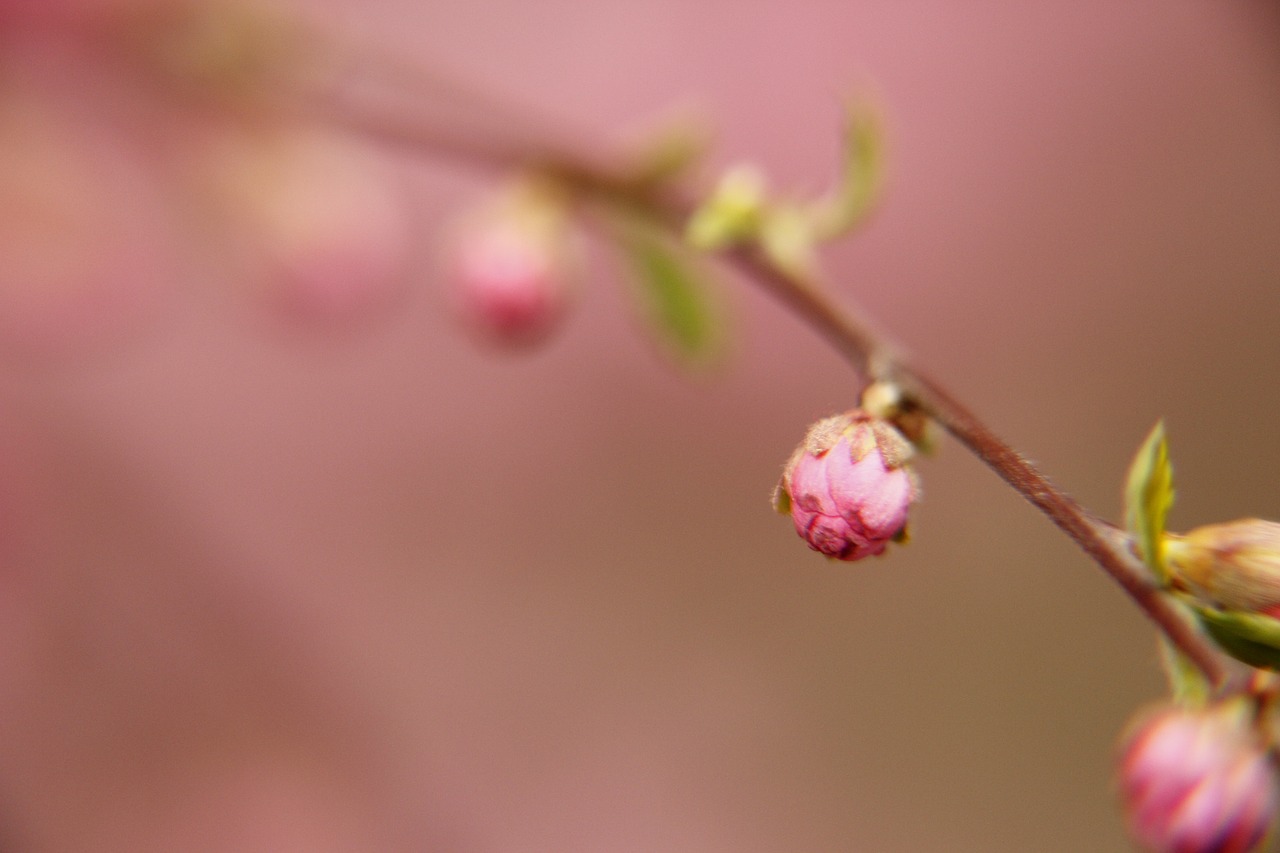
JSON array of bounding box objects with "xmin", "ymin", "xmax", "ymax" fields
[{"xmin": 1165, "ymin": 519, "xmax": 1280, "ymax": 616}]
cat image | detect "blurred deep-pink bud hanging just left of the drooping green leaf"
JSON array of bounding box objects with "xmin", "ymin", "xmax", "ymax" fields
[{"xmin": 451, "ymin": 188, "xmax": 576, "ymax": 346}]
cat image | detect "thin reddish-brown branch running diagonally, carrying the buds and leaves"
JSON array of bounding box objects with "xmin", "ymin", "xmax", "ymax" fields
[{"xmin": 296, "ymin": 38, "xmax": 1230, "ymax": 688}]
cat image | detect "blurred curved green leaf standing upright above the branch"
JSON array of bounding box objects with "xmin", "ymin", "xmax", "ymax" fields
[{"xmin": 814, "ymin": 102, "xmax": 886, "ymax": 240}]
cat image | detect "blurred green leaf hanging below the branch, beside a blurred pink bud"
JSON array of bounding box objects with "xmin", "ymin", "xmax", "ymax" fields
[{"xmin": 617, "ymin": 224, "xmax": 724, "ymax": 366}]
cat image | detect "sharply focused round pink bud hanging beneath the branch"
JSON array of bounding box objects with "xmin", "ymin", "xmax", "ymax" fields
[{"xmin": 773, "ymin": 410, "xmax": 919, "ymax": 560}]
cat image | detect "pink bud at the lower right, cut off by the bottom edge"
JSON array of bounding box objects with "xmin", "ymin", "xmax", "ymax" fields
[{"xmin": 1120, "ymin": 699, "xmax": 1277, "ymax": 853}]
